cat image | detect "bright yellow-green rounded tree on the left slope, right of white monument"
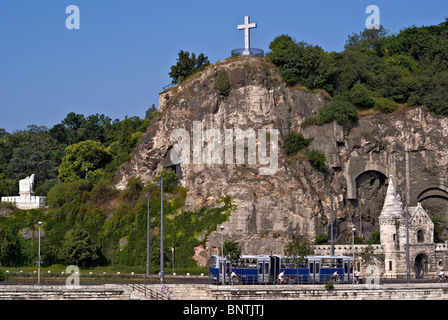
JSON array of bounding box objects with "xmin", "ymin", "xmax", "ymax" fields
[{"xmin": 58, "ymin": 140, "xmax": 111, "ymax": 181}]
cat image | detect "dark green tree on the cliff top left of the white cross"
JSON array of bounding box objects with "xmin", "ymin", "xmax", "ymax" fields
[{"xmin": 169, "ymin": 50, "xmax": 210, "ymax": 84}]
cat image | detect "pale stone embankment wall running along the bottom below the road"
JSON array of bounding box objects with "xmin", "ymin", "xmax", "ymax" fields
[{"xmin": 0, "ymin": 284, "xmax": 448, "ymax": 300}]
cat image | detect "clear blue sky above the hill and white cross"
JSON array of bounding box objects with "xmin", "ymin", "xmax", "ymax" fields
[{"xmin": 0, "ymin": 0, "xmax": 448, "ymax": 132}]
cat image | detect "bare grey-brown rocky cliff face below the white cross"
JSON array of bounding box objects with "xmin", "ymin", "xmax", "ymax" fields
[{"xmin": 116, "ymin": 58, "xmax": 448, "ymax": 264}]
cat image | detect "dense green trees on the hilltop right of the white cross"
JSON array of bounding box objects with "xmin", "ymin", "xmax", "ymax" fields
[{"xmin": 267, "ymin": 19, "xmax": 448, "ymax": 123}]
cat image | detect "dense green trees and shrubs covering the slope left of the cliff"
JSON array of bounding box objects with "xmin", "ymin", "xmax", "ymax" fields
[{"xmin": 0, "ymin": 105, "xmax": 236, "ymax": 273}]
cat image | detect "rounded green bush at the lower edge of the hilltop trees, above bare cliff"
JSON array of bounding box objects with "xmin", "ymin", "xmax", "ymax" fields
[{"xmin": 319, "ymin": 99, "xmax": 358, "ymax": 125}]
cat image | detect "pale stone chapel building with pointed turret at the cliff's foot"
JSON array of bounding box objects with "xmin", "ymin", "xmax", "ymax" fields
[{"xmin": 313, "ymin": 176, "xmax": 448, "ymax": 278}]
